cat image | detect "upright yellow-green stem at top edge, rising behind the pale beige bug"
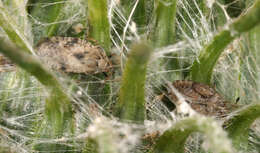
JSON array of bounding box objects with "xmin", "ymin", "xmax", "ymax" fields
[{"xmin": 87, "ymin": 0, "xmax": 110, "ymax": 56}]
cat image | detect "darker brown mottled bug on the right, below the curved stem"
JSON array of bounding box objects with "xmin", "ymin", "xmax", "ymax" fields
[{"xmin": 166, "ymin": 80, "xmax": 236, "ymax": 118}]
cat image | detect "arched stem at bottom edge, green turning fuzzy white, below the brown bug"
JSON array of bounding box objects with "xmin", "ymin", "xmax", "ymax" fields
[{"xmin": 150, "ymin": 115, "xmax": 233, "ymax": 153}]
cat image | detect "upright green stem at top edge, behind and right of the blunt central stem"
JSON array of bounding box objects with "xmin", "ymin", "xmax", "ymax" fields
[{"xmin": 150, "ymin": 0, "xmax": 181, "ymax": 78}]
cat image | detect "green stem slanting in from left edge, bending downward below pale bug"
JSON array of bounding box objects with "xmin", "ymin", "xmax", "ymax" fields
[{"xmin": 0, "ymin": 40, "xmax": 73, "ymax": 135}]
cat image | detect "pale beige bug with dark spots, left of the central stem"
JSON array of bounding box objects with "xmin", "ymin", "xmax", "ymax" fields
[{"xmin": 36, "ymin": 36, "xmax": 112, "ymax": 74}]
